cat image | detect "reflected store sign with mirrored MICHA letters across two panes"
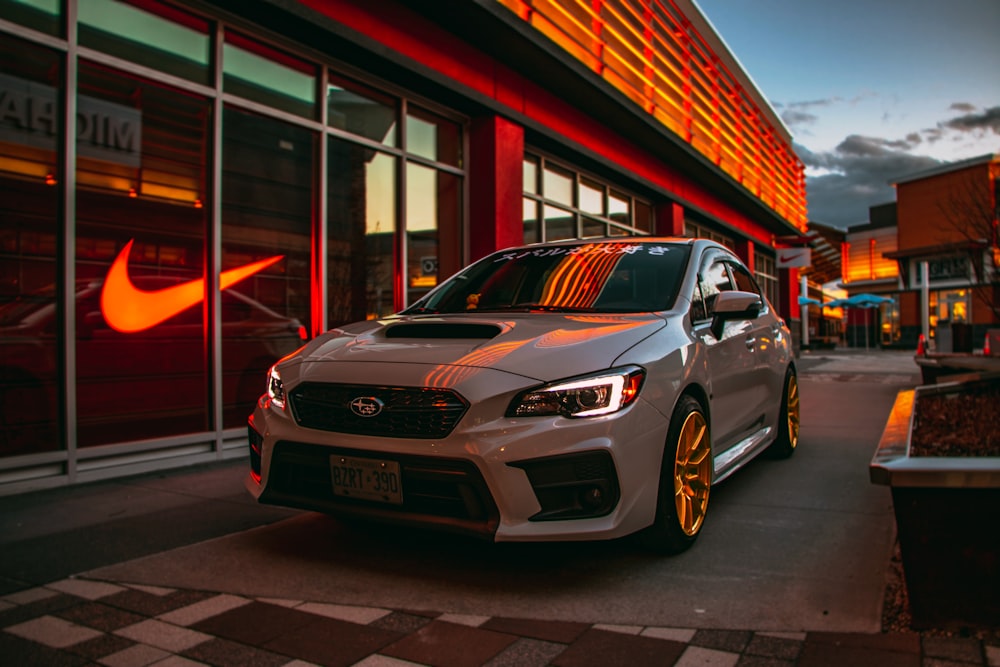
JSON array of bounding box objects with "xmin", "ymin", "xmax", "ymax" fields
[{"xmin": 0, "ymin": 74, "xmax": 142, "ymax": 167}]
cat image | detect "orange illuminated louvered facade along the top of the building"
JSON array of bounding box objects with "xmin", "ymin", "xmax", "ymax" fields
[{"xmin": 498, "ymin": 0, "xmax": 807, "ymax": 230}]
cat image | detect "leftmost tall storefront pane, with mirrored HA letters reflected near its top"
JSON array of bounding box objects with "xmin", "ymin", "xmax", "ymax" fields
[{"xmin": 0, "ymin": 35, "xmax": 63, "ymax": 456}]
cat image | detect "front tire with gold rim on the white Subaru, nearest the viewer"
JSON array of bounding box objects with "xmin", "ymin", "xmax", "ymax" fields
[{"xmin": 639, "ymin": 396, "xmax": 713, "ymax": 555}]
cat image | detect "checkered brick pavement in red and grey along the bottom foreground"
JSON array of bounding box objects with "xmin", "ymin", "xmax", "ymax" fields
[{"xmin": 0, "ymin": 578, "xmax": 1000, "ymax": 667}]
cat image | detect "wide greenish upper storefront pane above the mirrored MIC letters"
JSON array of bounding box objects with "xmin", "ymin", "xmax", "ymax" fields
[{"xmin": 77, "ymin": 0, "xmax": 211, "ymax": 84}]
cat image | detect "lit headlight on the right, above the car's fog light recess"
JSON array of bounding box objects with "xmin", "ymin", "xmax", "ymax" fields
[{"xmin": 506, "ymin": 366, "xmax": 646, "ymax": 417}]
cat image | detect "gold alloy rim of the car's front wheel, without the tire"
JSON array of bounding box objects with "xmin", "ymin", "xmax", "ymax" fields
[{"xmin": 674, "ymin": 412, "xmax": 712, "ymax": 537}]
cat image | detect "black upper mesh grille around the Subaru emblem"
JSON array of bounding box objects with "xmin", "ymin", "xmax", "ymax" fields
[{"xmin": 289, "ymin": 382, "xmax": 468, "ymax": 439}]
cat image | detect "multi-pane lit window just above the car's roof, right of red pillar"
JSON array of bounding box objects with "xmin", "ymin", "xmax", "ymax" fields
[{"xmin": 523, "ymin": 155, "xmax": 653, "ymax": 243}]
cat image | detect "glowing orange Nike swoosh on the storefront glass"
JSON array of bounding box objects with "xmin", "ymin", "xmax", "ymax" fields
[{"xmin": 101, "ymin": 239, "xmax": 284, "ymax": 333}]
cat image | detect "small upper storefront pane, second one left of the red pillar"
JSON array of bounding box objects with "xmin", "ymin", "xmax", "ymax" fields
[{"xmin": 326, "ymin": 76, "xmax": 399, "ymax": 146}]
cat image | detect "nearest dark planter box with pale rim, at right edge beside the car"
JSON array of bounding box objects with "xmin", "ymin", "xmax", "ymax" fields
[{"xmin": 869, "ymin": 379, "xmax": 1000, "ymax": 630}]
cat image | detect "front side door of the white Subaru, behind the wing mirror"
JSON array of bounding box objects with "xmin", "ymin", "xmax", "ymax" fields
[{"xmin": 692, "ymin": 251, "xmax": 759, "ymax": 457}]
